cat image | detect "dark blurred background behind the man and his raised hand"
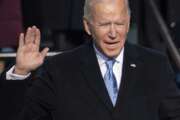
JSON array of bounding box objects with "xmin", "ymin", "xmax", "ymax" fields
[{"xmin": 0, "ymin": 0, "xmax": 180, "ymax": 120}]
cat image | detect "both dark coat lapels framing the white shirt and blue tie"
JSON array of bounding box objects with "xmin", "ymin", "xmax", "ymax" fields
[{"xmin": 81, "ymin": 43, "xmax": 141, "ymax": 116}]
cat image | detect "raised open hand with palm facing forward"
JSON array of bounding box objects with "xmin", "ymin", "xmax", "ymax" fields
[{"xmin": 14, "ymin": 26, "xmax": 49, "ymax": 75}]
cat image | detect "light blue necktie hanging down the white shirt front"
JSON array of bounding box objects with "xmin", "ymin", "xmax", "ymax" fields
[{"xmin": 104, "ymin": 59, "xmax": 118, "ymax": 106}]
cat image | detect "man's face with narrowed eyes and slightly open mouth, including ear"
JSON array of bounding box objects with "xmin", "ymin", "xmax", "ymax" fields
[{"xmin": 84, "ymin": 0, "xmax": 130, "ymax": 57}]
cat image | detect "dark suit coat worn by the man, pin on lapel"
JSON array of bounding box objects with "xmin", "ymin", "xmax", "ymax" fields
[{"xmin": 17, "ymin": 43, "xmax": 180, "ymax": 120}]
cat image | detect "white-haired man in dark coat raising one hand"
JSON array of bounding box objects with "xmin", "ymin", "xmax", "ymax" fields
[{"xmin": 3, "ymin": 0, "xmax": 180, "ymax": 120}]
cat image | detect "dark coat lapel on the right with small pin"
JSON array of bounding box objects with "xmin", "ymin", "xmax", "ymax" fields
[{"xmin": 114, "ymin": 43, "xmax": 140, "ymax": 116}]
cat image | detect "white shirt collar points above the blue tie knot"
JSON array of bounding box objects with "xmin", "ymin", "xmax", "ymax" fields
[{"xmin": 93, "ymin": 44, "xmax": 124, "ymax": 65}]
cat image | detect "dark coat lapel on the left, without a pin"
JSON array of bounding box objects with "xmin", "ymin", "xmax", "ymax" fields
[{"xmin": 81, "ymin": 44, "xmax": 113, "ymax": 111}]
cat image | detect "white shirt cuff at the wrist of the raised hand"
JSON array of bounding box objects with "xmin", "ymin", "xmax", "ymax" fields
[{"xmin": 6, "ymin": 66, "xmax": 31, "ymax": 80}]
